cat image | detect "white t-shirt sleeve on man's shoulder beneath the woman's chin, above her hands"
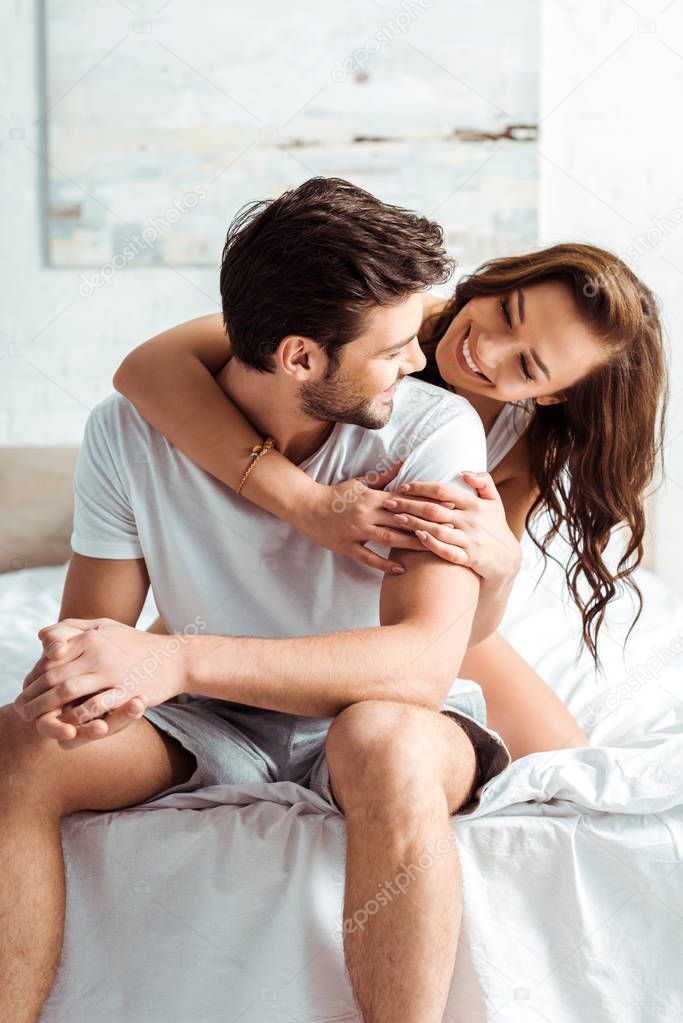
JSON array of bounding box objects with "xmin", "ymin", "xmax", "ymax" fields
[{"xmin": 386, "ymin": 399, "xmax": 487, "ymax": 493}]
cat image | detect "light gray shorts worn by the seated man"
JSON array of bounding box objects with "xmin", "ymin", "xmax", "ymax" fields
[{"xmin": 141, "ymin": 678, "xmax": 511, "ymax": 813}]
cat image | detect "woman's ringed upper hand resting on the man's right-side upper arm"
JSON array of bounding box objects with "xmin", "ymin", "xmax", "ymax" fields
[{"xmin": 382, "ymin": 473, "xmax": 521, "ymax": 584}]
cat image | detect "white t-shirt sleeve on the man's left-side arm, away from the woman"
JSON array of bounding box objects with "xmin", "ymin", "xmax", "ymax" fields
[{"xmin": 72, "ymin": 406, "xmax": 143, "ymax": 560}]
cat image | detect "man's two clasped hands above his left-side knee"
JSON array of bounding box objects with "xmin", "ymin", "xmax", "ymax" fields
[{"xmin": 14, "ymin": 618, "xmax": 185, "ymax": 746}]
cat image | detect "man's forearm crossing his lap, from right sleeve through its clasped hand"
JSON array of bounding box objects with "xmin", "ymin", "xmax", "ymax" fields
[{"xmin": 18, "ymin": 551, "xmax": 480, "ymax": 739}]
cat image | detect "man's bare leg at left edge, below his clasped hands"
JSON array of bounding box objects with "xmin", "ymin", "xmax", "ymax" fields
[{"xmin": 0, "ymin": 706, "xmax": 195, "ymax": 1023}]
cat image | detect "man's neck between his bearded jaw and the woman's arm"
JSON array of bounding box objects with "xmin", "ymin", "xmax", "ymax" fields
[{"xmin": 218, "ymin": 358, "xmax": 334, "ymax": 464}]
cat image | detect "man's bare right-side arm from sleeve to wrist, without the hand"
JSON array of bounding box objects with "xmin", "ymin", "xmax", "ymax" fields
[{"xmin": 181, "ymin": 551, "xmax": 479, "ymax": 717}]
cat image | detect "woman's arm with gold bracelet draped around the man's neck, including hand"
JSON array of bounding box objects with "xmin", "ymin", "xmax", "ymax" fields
[{"xmin": 113, "ymin": 313, "xmax": 421, "ymax": 572}]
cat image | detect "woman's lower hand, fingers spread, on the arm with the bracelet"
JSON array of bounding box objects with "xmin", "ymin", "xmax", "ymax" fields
[{"xmin": 294, "ymin": 463, "xmax": 424, "ymax": 574}]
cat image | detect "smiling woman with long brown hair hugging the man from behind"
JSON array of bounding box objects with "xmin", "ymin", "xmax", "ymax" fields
[{"xmin": 115, "ymin": 243, "xmax": 666, "ymax": 759}]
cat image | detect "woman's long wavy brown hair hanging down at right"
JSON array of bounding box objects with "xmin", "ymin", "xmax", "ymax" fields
[{"xmin": 418, "ymin": 242, "xmax": 668, "ymax": 664}]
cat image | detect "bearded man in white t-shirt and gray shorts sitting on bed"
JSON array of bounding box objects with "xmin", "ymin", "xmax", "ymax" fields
[{"xmin": 0, "ymin": 179, "xmax": 509, "ymax": 1023}]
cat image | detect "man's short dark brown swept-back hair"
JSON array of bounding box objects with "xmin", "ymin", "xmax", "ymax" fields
[{"xmin": 221, "ymin": 177, "xmax": 453, "ymax": 372}]
